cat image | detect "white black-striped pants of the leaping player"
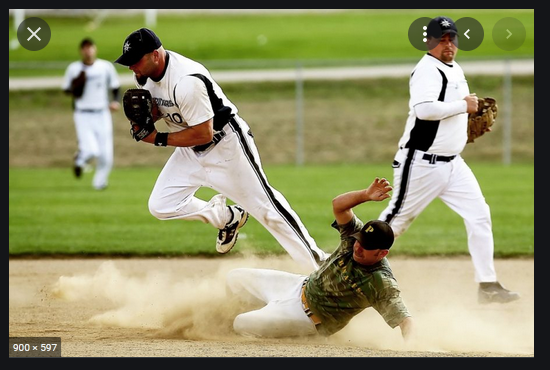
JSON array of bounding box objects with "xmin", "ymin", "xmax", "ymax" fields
[{"xmin": 149, "ymin": 116, "xmax": 328, "ymax": 271}]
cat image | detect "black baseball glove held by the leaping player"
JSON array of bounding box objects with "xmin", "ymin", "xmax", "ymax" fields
[{"xmin": 122, "ymin": 89, "xmax": 155, "ymax": 141}]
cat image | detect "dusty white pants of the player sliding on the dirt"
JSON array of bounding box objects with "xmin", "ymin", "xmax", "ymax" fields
[{"xmin": 226, "ymin": 268, "xmax": 317, "ymax": 338}]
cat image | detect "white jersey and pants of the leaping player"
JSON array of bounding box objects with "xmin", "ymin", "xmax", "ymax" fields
[{"xmin": 140, "ymin": 51, "xmax": 327, "ymax": 271}]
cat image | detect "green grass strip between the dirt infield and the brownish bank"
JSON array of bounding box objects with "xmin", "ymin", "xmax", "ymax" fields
[{"xmin": 9, "ymin": 164, "xmax": 534, "ymax": 257}]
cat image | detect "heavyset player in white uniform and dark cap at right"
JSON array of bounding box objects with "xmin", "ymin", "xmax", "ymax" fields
[{"xmin": 379, "ymin": 17, "xmax": 519, "ymax": 303}]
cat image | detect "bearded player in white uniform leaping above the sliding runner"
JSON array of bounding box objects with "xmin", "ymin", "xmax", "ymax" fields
[{"xmin": 115, "ymin": 28, "xmax": 328, "ymax": 271}]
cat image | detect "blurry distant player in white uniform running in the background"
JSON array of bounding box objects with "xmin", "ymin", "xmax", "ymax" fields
[{"xmin": 62, "ymin": 38, "xmax": 120, "ymax": 190}]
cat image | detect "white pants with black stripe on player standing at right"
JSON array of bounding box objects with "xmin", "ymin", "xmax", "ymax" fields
[{"xmin": 379, "ymin": 149, "xmax": 497, "ymax": 282}]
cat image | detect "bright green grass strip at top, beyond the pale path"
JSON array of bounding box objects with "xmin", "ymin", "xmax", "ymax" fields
[{"xmin": 9, "ymin": 9, "xmax": 534, "ymax": 77}]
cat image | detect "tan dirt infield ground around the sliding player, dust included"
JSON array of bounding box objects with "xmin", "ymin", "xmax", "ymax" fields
[{"xmin": 9, "ymin": 254, "xmax": 535, "ymax": 357}]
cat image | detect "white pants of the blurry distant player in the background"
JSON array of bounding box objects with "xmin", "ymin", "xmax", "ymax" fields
[{"xmin": 73, "ymin": 109, "xmax": 113, "ymax": 189}]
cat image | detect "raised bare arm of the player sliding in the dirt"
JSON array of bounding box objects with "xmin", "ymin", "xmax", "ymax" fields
[{"xmin": 332, "ymin": 177, "xmax": 392, "ymax": 225}]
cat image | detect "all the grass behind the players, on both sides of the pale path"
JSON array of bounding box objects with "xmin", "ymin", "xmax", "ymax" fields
[{"xmin": 9, "ymin": 9, "xmax": 534, "ymax": 257}]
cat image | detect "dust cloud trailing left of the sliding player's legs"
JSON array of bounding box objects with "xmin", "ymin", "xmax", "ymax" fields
[{"xmin": 52, "ymin": 256, "xmax": 302, "ymax": 340}]
